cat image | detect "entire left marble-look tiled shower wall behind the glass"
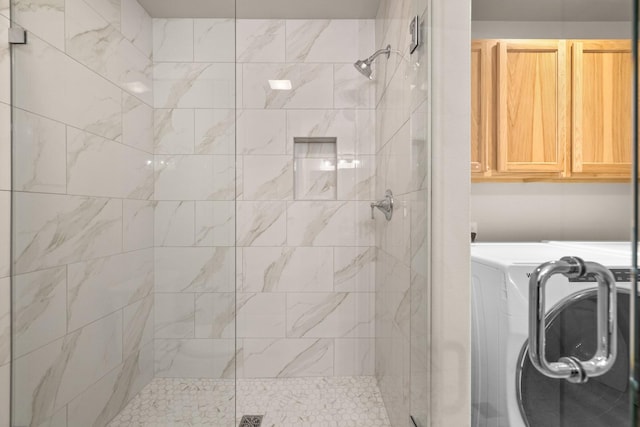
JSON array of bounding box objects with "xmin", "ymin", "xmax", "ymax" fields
[{"xmin": 2, "ymin": 0, "xmax": 154, "ymax": 426}]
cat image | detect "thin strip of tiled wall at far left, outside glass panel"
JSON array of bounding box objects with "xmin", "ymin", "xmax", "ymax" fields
[{"xmin": 0, "ymin": 0, "xmax": 11, "ymax": 427}]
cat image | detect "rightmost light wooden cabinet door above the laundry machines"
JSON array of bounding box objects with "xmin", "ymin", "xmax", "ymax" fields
[{"xmin": 571, "ymin": 40, "xmax": 632, "ymax": 176}]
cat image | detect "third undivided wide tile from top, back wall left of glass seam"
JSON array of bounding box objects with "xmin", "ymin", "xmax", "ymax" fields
[{"xmin": 155, "ymin": 247, "xmax": 235, "ymax": 292}]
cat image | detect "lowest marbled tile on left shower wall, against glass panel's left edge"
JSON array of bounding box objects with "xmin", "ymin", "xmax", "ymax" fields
[{"xmin": 13, "ymin": 312, "xmax": 122, "ymax": 425}]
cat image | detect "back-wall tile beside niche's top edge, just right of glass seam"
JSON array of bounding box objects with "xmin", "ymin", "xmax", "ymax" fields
[{"xmin": 237, "ymin": 110, "xmax": 287, "ymax": 155}]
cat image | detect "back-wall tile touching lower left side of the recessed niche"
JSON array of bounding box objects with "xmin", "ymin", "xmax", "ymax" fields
[{"xmin": 242, "ymin": 156, "xmax": 293, "ymax": 200}]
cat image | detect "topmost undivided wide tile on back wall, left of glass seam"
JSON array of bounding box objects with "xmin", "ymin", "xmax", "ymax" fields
[{"xmin": 153, "ymin": 62, "xmax": 236, "ymax": 108}]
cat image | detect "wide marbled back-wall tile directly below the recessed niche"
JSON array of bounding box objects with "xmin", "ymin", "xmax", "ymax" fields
[{"xmin": 287, "ymin": 201, "xmax": 356, "ymax": 246}]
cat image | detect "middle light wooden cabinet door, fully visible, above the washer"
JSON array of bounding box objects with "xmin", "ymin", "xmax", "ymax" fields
[{"xmin": 497, "ymin": 40, "xmax": 567, "ymax": 177}]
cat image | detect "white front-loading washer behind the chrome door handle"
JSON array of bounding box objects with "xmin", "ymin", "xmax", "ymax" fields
[{"xmin": 471, "ymin": 243, "xmax": 630, "ymax": 427}]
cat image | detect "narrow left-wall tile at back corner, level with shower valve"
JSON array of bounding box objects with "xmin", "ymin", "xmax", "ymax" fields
[{"xmin": 122, "ymin": 200, "xmax": 155, "ymax": 252}]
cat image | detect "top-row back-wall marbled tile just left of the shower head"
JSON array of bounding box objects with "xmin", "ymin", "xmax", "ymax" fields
[{"xmin": 286, "ymin": 19, "xmax": 359, "ymax": 63}]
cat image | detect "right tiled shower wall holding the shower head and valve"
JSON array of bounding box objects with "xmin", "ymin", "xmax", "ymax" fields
[{"xmin": 375, "ymin": 0, "xmax": 431, "ymax": 426}]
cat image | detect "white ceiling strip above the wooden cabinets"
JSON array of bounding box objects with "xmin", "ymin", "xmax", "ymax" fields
[{"xmin": 471, "ymin": 0, "xmax": 632, "ymax": 21}]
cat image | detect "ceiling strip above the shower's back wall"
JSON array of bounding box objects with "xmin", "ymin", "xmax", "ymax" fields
[{"xmin": 138, "ymin": 0, "xmax": 380, "ymax": 19}]
